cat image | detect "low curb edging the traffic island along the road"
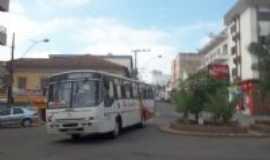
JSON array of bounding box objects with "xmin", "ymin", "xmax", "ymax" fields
[{"xmin": 159, "ymin": 125, "xmax": 270, "ymax": 138}]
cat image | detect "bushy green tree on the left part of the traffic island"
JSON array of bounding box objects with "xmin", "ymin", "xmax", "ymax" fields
[{"xmin": 176, "ymin": 72, "xmax": 228, "ymax": 122}]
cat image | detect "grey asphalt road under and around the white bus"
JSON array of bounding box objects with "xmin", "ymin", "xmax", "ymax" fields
[{"xmin": 0, "ymin": 104, "xmax": 270, "ymax": 160}]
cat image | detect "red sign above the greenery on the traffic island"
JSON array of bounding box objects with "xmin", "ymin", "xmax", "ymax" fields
[{"xmin": 209, "ymin": 64, "xmax": 229, "ymax": 80}]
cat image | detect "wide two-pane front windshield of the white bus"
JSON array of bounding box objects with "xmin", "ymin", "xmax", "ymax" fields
[{"xmin": 48, "ymin": 80, "xmax": 100, "ymax": 109}]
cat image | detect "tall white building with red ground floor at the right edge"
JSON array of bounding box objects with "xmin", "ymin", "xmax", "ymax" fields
[{"xmin": 224, "ymin": 0, "xmax": 270, "ymax": 114}]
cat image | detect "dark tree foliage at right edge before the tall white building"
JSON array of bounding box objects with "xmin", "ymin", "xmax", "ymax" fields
[{"xmin": 249, "ymin": 35, "xmax": 270, "ymax": 95}]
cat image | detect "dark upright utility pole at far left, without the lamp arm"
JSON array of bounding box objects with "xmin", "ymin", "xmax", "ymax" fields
[{"xmin": 8, "ymin": 33, "xmax": 15, "ymax": 107}]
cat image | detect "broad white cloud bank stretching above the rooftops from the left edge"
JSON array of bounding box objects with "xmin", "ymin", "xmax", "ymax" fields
[{"xmin": 0, "ymin": 0, "xmax": 224, "ymax": 80}]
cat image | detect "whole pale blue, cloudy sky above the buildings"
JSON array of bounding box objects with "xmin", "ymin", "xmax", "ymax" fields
[{"xmin": 0, "ymin": 0, "xmax": 236, "ymax": 82}]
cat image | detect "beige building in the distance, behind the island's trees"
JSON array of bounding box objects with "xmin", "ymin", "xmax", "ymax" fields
[{"xmin": 171, "ymin": 53, "xmax": 203, "ymax": 89}]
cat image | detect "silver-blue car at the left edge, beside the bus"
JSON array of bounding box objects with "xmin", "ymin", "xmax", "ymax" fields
[{"xmin": 0, "ymin": 107, "xmax": 39, "ymax": 127}]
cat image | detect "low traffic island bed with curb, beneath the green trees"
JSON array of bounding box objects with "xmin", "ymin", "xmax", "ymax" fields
[{"xmin": 160, "ymin": 120, "xmax": 270, "ymax": 138}]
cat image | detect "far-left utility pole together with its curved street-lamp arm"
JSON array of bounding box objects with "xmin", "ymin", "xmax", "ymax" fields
[{"xmin": 7, "ymin": 33, "xmax": 49, "ymax": 107}]
